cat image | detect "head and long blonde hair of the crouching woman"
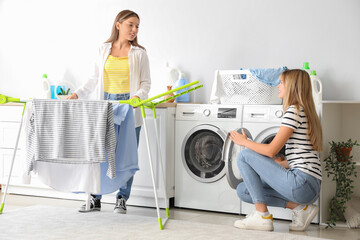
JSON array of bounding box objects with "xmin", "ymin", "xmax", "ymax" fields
[{"xmin": 280, "ymin": 69, "xmax": 323, "ymax": 152}]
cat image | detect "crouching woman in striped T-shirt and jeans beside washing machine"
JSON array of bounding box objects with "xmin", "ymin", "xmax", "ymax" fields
[{"xmin": 230, "ymin": 69, "xmax": 322, "ymax": 231}]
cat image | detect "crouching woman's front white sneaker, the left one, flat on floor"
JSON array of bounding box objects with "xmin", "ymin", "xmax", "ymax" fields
[{"xmin": 234, "ymin": 210, "xmax": 274, "ymax": 231}]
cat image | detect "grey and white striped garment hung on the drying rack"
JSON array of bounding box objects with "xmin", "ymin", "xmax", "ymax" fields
[{"xmin": 27, "ymin": 99, "xmax": 116, "ymax": 178}]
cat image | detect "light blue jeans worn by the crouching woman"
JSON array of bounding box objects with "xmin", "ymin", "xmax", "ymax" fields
[{"xmin": 236, "ymin": 149, "xmax": 321, "ymax": 208}]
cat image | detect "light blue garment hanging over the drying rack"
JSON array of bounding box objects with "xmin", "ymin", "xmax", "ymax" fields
[{"xmin": 97, "ymin": 104, "xmax": 139, "ymax": 195}]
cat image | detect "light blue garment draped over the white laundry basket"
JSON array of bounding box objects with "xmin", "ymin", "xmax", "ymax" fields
[{"xmin": 249, "ymin": 66, "xmax": 288, "ymax": 87}]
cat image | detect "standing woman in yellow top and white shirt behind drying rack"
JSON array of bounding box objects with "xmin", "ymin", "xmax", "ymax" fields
[{"xmin": 68, "ymin": 10, "xmax": 151, "ymax": 214}]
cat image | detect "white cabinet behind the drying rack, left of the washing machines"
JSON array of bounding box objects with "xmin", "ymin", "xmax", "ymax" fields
[{"xmin": 0, "ymin": 105, "xmax": 175, "ymax": 207}]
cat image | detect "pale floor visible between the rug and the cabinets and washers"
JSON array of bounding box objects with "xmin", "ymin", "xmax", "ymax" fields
[{"xmin": 4, "ymin": 195, "xmax": 360, "ymax": 240}]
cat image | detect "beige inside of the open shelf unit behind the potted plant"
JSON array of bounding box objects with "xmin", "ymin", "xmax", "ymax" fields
[{"xmin": 320, "ymin": 101, "xmax": 360, "ymax": 223}]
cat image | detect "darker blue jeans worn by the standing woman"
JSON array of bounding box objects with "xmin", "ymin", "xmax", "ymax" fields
[{"xmin": 93, "ymin": 92, "xmax": 141, "ymax": 200}]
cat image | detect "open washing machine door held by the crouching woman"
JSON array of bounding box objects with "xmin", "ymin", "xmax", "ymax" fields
[{"xmin": 223, "ymin": 128, "xmax": 253, "ymax": 189}]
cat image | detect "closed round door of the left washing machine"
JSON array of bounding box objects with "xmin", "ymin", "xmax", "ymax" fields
[{"xmin": 181, "ymin": 124, "xmax": 226, "ymax": 183}]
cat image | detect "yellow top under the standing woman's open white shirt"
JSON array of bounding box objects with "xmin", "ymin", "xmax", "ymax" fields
[{"xmin": 104, "ymin": 55, "xmax": 130, "ymax": 94}]
